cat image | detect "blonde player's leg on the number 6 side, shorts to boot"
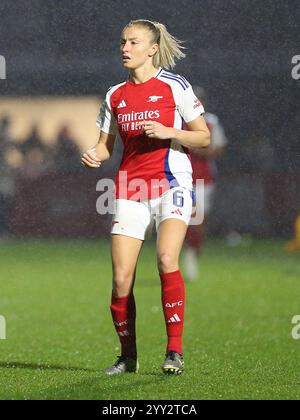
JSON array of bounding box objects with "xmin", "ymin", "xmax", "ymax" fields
[{"xmin": 154, "ymin": 187, "xmax": 193, "ymax": 374}]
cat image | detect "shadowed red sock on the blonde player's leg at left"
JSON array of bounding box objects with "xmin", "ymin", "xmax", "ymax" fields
[{"xmin": 110, "ymin": 293, "xmax": 137, "ymax": 358}]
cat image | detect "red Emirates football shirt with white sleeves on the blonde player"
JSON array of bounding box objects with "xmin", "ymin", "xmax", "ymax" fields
[{"xmin": 97, "ymin": 68, "xmax": 204, "ymax": 200}]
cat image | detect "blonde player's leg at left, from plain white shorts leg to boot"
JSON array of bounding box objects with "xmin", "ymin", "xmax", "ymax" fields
[{"xmin": 105, "ymin": 200, "xmax": 150, "ymax": 375}]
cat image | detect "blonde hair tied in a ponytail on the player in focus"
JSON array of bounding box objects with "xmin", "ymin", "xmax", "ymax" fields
[{"xmin": 124, "ymin": 19, "xmax": 185, "ymax": 69}]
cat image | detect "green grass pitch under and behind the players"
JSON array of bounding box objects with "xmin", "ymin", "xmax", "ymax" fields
[{"xmin": 0, "ymin": 240, "xmax": 300, "ymax": 400}]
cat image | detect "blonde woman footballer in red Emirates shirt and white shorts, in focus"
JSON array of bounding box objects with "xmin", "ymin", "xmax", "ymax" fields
[{"xmin": 82, "ymin": 20, "xmax": 210, "ymax": 375}]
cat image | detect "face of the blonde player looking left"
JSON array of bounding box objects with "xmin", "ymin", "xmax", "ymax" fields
[{"xmin": 120, "ymin": 26, "xmax": 158, "ymax": 70}]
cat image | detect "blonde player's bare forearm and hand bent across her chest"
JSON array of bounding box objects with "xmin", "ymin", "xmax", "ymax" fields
[{"xmin": 140, "ymin": 116, "xmax": 210, "ymax": 148}]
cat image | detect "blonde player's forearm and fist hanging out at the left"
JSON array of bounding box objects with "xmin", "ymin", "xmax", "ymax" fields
[{"xmin": 81, "ymin": 131, "xmax": 116, "ymax": 168}]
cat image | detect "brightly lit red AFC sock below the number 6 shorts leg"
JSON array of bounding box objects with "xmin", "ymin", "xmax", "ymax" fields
[{"xmin": 160, "ymin": 270, "xmax": 185, "ymax": 354}]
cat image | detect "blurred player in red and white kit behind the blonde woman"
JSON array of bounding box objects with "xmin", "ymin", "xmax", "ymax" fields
[{"xmin": 184, "ymin": 86, "xmax": 227, "ymax": 281}]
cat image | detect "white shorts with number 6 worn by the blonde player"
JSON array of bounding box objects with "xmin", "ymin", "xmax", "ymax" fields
[{"xmin": 111, "ymin": 187, "xmax": 193, "ymax": 241}]
